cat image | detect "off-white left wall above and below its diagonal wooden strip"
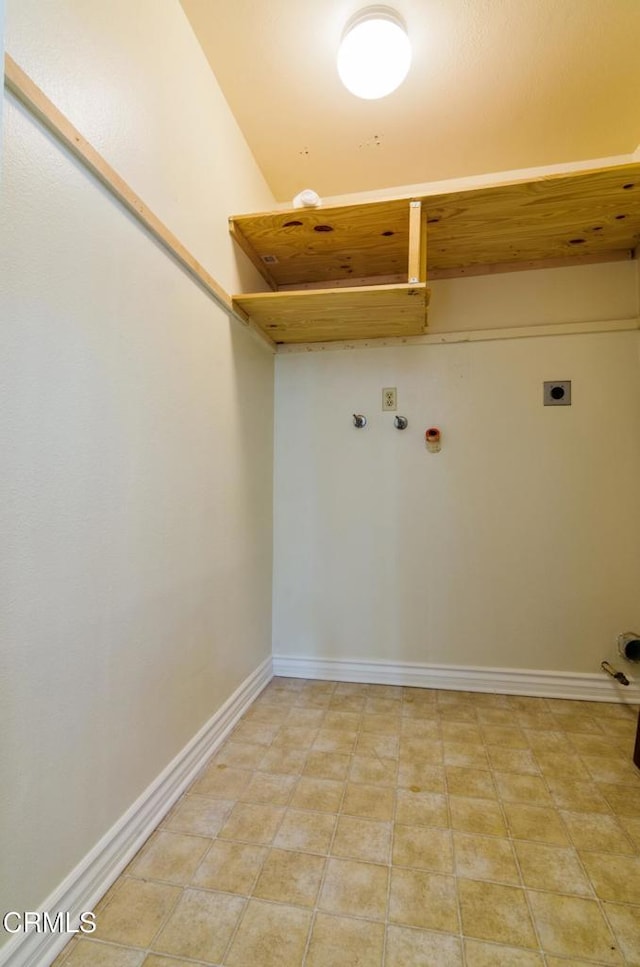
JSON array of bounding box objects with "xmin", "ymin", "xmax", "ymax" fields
[{"xmin": 0, "ymin": 0, "xmax": 273, "ymax": 942}]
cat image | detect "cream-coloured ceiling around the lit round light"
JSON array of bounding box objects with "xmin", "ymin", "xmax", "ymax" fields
[{"xmin": 181, "ymin": 0, "xmax": 640, "ymax": 201}]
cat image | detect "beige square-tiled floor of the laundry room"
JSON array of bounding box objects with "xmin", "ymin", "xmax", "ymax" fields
[{"xmin": 51, "ymin": 679, "xmax": 640, "ymax": 967}]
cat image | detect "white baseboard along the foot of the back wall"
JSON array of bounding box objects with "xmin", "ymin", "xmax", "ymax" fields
[{"xmin": 273, "ymin": 655, "xmax": 640, "ymax": 705}]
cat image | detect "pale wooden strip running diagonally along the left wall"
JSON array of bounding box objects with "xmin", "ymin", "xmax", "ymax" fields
[{"xmin": 4, "ymin": 54, "xmax": 275, "ymax": 352}]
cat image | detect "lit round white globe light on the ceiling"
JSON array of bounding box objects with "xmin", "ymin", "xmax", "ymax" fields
[{"xmin": 338, "ymin": 6, "xmax": 411, "ymax": 100}]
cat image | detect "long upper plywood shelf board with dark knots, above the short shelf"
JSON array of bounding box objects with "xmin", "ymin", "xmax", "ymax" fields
[{"xmin": 231, "ymin": 164, "xmax": 640, "ymax": 286}]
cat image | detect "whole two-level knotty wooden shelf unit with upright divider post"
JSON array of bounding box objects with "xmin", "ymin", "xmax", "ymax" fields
[{"xmin": 230, "ymin": 164, "xmax": 640, "ymax": 342}]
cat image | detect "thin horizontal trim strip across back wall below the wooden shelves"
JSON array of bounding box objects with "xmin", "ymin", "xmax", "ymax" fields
[{"xmin": 276, "ymin": 318, "xmax": 640, "ymax": 356}]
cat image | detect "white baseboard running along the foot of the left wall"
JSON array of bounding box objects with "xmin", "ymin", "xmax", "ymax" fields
[{"xmin": 0, "ymin": 658, "xmax": 273, "ymax": 967}]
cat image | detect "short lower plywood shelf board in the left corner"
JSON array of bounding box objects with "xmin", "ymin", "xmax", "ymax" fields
[{"xmin": 233, "ymin": 284, "xmax": 429, "ymax": 343}]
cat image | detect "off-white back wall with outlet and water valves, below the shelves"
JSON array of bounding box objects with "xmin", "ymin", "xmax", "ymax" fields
[{"xmin": 274, "ymin": 266, "xmax": 640, "ymax": 672}]
